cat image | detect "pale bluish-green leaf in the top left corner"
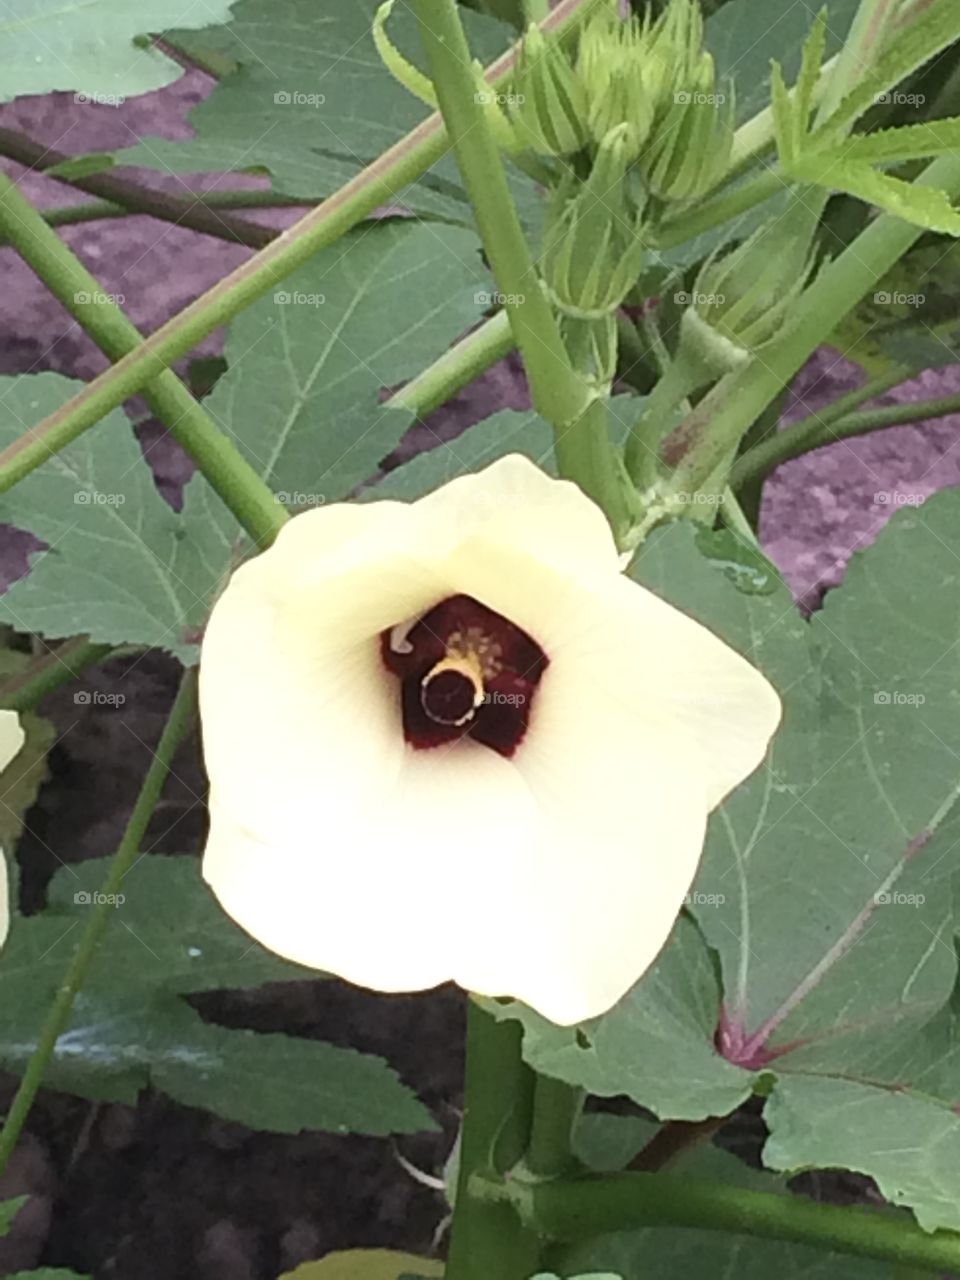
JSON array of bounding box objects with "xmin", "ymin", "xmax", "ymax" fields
[{"xmin": 0, "ymin": 0, "xmax": 230, "ymax": 105}]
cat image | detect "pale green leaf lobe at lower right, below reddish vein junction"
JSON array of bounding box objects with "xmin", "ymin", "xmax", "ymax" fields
[{"xmin": 763, "ymin": 1076, "xmax": 960, "ymax": 1231}]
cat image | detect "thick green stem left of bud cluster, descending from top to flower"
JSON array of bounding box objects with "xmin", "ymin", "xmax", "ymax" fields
[{"xmin": 411, "ymin": 0, "xmax": 627, "ymax": 529}]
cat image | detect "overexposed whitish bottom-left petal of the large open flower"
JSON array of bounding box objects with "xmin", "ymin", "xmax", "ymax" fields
[{"xmin": 204, "ymin": 740, "xmax": 539, "ymax": 991}]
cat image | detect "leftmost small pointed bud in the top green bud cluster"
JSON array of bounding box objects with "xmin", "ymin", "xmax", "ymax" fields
[{"xmin": 511, "ymin": 26, "xmax": 588, "ymax": 156}]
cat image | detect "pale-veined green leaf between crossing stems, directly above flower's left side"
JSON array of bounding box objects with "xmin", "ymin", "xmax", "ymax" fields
[{"xmin": 204, "ymin": 221, "xmax": 489, "ymax": 508}]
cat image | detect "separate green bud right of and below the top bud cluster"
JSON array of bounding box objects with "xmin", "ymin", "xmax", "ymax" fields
[{"xmin": 681, "ymin": 216, "xmax": 814, "ymax": 366}]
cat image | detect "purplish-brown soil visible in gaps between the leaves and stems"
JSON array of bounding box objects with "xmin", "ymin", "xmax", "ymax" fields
[{"xmin": 0, "ymin": 73, "xmax": 960, "ymax": 1280}]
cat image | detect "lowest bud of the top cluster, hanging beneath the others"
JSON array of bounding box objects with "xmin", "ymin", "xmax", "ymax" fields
[{"xmin": 541, "ymin": 124, "xmax": 644, "ymax": 320}]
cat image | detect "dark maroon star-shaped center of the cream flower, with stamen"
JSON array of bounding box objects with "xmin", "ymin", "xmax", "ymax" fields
[{"xmin": 380, "ymin": 595, "xmax": 549, "ymax": 756}]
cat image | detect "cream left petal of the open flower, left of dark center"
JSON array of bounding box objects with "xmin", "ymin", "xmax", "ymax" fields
[{"xmin": 200, "ymin": 503, "xmax": 449, "ymax": 838}]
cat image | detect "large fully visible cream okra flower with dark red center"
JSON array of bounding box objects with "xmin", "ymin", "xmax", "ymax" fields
[{"xmin": 200, "ymin": 456, "xmax": 780, "ymax": 1024}]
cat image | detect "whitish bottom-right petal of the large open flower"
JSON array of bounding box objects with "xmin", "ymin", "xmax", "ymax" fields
[{"xmin": 504, "ymin": 686, "xmax": 707, "ymax": 1025}]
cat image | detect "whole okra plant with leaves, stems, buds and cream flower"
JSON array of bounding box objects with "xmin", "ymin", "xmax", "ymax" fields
[{"xmin": 0, "ymin": 0, "xmax": 960, "ymax": 1280}]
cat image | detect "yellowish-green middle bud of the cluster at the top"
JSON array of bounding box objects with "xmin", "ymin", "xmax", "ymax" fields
[{"xmin": 577, "ymin": 10, "xmax": 654, "ymax": 163}]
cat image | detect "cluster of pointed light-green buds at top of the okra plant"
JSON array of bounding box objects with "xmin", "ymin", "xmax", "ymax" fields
[{"xmin": 507, "ymin": 0, "xmax": 733, "ymax": 325}]
